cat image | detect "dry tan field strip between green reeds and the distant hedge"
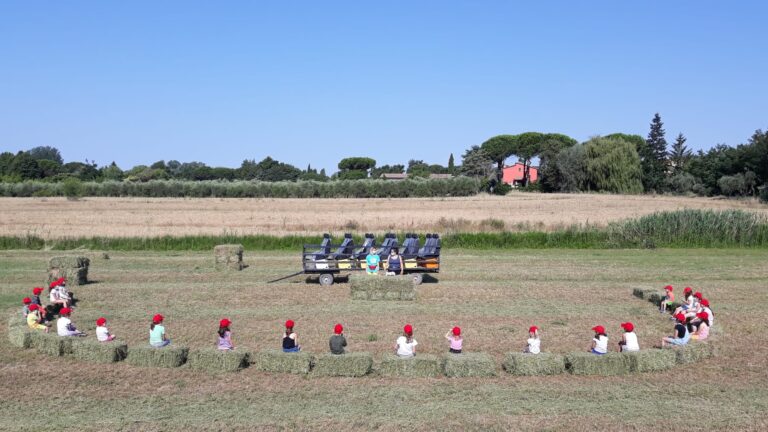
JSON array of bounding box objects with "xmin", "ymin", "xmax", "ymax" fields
[{"xmin": 0, "ymin": 192, "xmax": 768, "ymax": 239}]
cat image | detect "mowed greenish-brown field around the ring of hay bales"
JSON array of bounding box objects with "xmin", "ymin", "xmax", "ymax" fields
[{"xmin": 0, "ymin": 250, "xmax": 768, "ymax": 431}]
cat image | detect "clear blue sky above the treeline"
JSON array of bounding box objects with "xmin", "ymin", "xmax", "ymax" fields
[{"xmin": 0, "ymin": 0, "xmax": 768, "ymax": 172}]
